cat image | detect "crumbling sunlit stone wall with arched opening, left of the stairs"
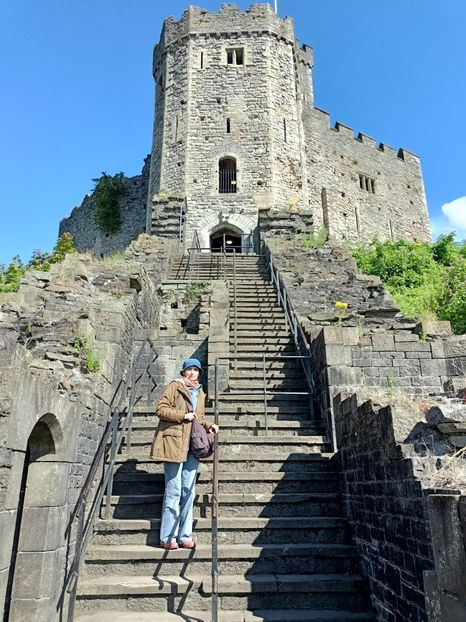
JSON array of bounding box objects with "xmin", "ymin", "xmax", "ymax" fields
[{"xmin": 0, "ymin": 237, "xmax": 172, "ymax": 622}]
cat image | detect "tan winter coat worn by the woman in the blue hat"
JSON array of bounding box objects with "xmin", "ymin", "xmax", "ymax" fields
[{"xmin": 150, "ymin": 380, "xmax": 212, "ymax": 462}]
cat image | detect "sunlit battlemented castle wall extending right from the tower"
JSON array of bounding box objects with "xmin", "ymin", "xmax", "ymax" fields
[{"xmin": 305, "ymin": 108, "xmax": 431, "ymax": 241}]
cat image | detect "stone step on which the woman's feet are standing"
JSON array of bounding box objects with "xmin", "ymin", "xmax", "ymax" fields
[{"xmin": 82, "ymin": 543, "xmax": 358, "ymax": 579}]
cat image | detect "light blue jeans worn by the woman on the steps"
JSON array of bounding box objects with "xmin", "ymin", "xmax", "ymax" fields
[{"xmin": 160, "ymin": 452, "xmax": 199, "ymax": 544}]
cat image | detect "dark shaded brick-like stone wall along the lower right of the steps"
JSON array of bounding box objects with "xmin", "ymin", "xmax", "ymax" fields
[{"xmin": 334, "ymin": 396, "xmax": 436, "ymax": 622}]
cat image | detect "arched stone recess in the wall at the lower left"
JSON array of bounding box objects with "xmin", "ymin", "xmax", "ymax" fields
[{"xmin": 5, "ymin": 413, "xmax": 69, "ymax": 622}]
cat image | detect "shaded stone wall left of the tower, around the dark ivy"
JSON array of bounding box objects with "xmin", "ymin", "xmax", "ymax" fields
[{"xmin": 58, "ymin": 157, "xmax": 150, "ymax": 257}]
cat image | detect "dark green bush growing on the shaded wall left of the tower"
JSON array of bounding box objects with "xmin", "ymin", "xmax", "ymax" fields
[{"xmin": 92, "ymin": 172, "xmax": 124, "ymax": 234}]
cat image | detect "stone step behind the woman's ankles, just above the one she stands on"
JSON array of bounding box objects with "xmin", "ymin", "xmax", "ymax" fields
[{"xmin": 92, "ymin": 515, "xmax": 349, "ymax": 546}]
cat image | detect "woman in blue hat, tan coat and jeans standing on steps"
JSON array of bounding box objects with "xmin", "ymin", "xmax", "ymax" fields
[{"xmin": 150, "ymin": 359, "xmax": 218, "ymax": 550}]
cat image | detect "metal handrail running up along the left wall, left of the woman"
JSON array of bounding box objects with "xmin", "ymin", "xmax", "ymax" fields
[{"xmin": 65, "ymin": 339, "xmax": 157, "ymax": 622}]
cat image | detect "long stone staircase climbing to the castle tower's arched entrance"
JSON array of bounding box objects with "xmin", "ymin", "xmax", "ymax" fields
[{"xmin": 77, "ymin": 255, "xmax": 375, "ymax": 622}]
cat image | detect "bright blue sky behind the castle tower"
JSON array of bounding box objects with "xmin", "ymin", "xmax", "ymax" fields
[{"xmin": 0, "ymin": 0, "xmax": 466, "ymax": 263}]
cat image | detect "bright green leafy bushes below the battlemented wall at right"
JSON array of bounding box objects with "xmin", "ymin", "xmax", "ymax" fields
[{"xmin": 352, "ymin": 233, "xmax": 466, "ymax": 334}]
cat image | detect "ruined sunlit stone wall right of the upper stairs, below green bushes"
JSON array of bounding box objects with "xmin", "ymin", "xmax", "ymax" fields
[{"xmin": 267, "ymin": 241, "xmax": 466, "ymax": 422}]
